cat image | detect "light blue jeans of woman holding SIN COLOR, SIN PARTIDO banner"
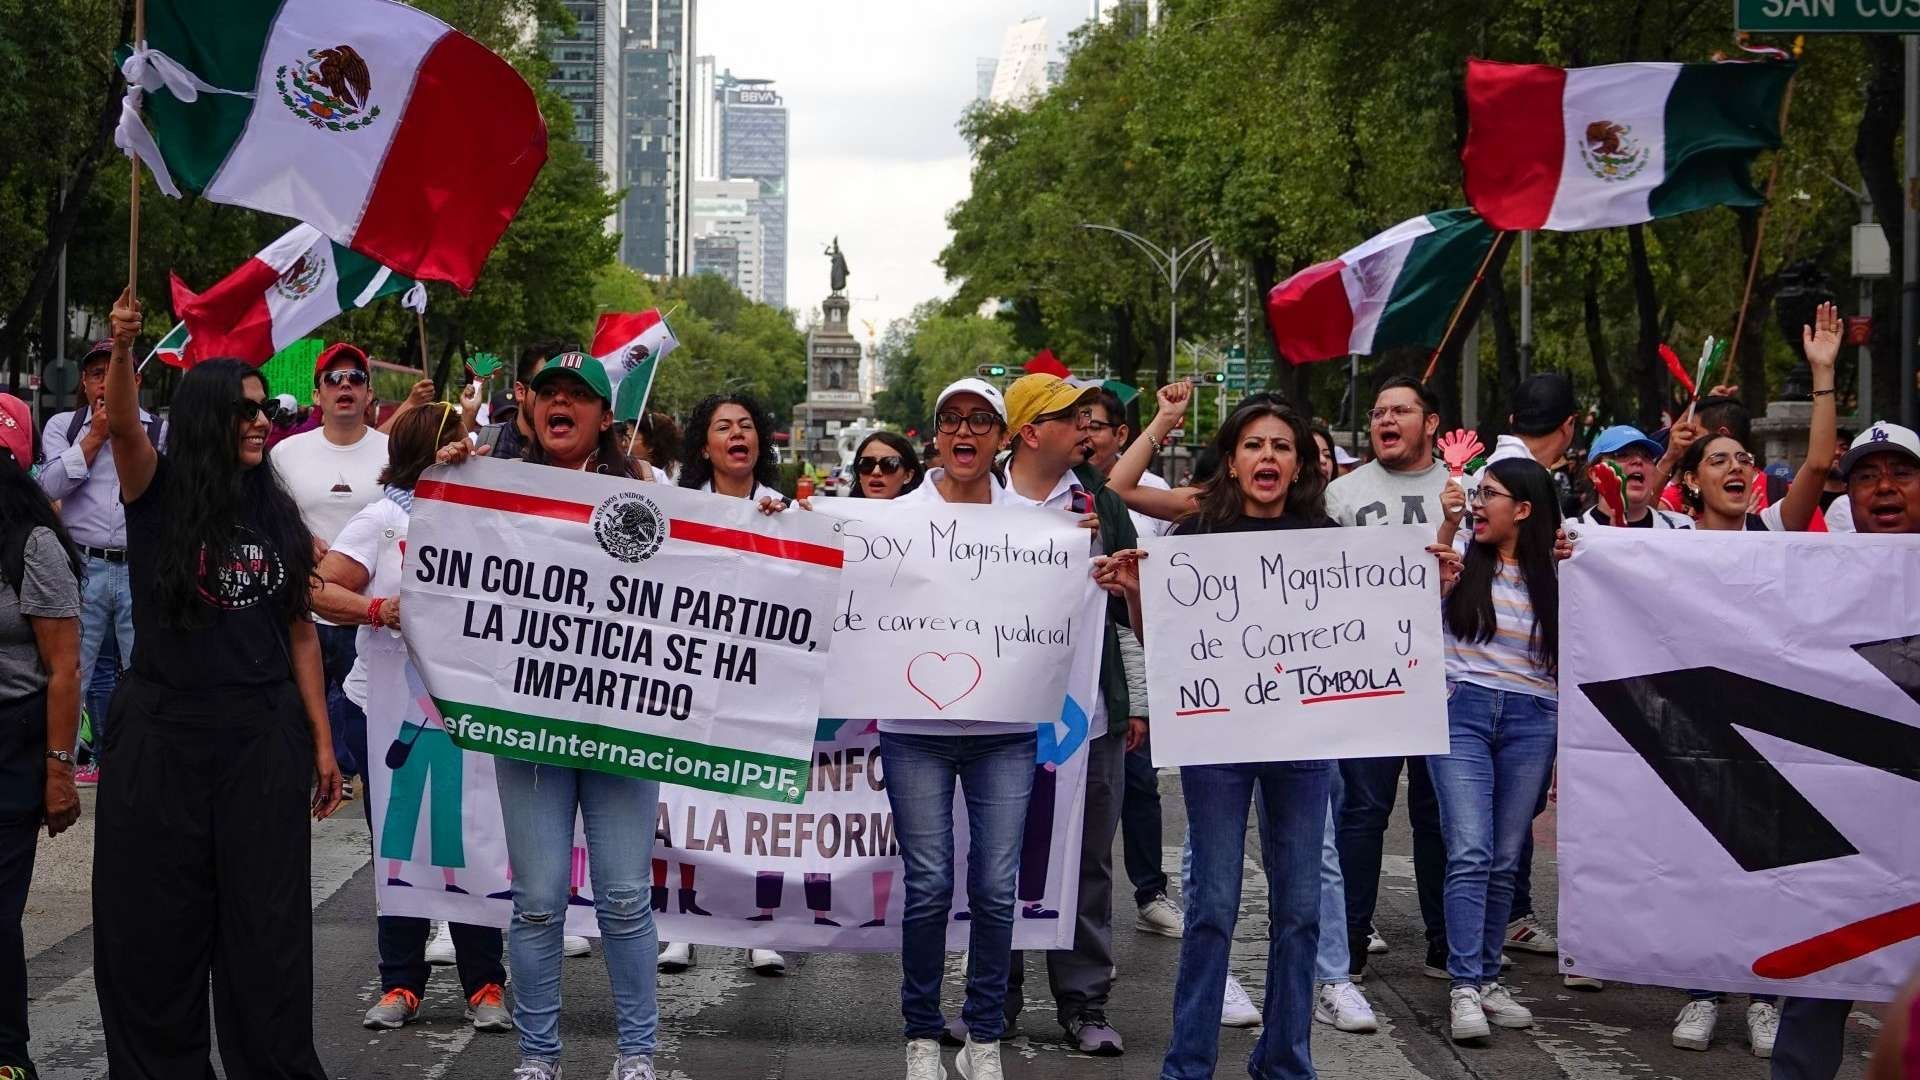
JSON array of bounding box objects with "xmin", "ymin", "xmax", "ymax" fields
[{"xmin": 493, "ymin": 757, "xmax": 660, "ymax": 1063}]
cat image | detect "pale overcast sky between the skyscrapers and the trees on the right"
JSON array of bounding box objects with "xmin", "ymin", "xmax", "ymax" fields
[{"xmin": 695, "ymin": 0, "xmax": 1091, "ymax": 338}]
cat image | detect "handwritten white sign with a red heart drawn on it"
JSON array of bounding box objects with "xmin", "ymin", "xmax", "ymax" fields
[{"xmin": 814, "ymin": 500, "xmax": 1102, "ymax": 724}]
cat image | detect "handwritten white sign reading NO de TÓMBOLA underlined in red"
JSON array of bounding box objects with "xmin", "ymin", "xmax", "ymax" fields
[{"xmin": 1140, "ymin": 525, "xmax": 1448, "ymax": 765}]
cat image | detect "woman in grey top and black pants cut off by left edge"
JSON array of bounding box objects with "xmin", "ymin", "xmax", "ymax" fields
[{"xmin": 0, "ymin": 394, "xmax": 84, "ymax": 1076}]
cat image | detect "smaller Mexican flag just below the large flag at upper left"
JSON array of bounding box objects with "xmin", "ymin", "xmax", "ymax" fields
[{"xmin": 169, "ymin": 225, "xmax": 426, "ymax": 367}]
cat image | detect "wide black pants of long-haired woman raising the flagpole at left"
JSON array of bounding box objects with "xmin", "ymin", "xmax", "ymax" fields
[{"xmin": 94, "ymin": 673, "xmax": 326, "ymax": 1080}]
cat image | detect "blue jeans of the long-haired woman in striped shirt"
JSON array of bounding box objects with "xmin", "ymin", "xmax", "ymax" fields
[{"xmin": 1427, "ymin": 682, "xmax": 1559, "ymax": 986}]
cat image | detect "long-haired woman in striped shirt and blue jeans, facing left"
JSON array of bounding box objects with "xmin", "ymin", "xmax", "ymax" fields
[{"xmin": 1427, "ymin": 457, "xmax": 1559, "ymax": 1040}]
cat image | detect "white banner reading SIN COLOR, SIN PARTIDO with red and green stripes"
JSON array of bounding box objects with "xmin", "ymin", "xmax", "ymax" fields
[{"xmin": 401, "ymin": 459, "xmax": 841, "ymax": 803}]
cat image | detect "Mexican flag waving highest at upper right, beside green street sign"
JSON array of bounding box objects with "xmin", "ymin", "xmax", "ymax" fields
[{"xmin": 1461, "ymin": 60, "xmax": 1793, "ymax": 233}]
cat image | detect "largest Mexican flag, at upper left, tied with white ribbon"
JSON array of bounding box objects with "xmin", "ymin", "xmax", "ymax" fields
[{"xmin": 115, "ymin": 0, "xmax": 547, "ymax": 292}]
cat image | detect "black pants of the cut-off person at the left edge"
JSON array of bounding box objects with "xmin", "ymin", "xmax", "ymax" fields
[{"xmin": 0, "ymin": 694, "xmax": 46, "ymax": 1076}]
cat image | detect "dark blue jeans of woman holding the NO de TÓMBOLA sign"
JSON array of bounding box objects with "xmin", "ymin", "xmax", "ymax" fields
[{"xmin": 1160, "ymin": 761, "xmax": 1332, "ymax": 1080}]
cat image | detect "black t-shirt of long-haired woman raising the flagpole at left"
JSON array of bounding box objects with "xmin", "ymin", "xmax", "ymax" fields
[{"xmin": 127, "ymin": 454, "xmax": 294, "ymax": 690}]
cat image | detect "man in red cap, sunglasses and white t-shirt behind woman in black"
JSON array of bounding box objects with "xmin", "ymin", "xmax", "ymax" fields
[{"xmin": 267, "ymin": 342, "xmax": 386, "ymax": 776}]
